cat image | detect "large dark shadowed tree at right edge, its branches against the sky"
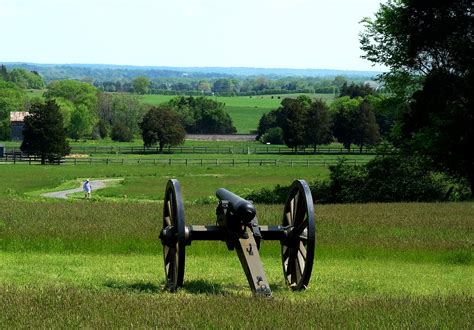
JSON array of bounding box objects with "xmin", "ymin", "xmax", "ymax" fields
[{"xmin": 361, "ymin": 0, "xmax": 474, "ymax": 194}]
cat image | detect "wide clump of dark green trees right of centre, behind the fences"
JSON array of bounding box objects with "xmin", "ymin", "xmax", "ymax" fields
[{"xmin": 257, "ymin": 84, "xmax": 386, "ymax": 152}]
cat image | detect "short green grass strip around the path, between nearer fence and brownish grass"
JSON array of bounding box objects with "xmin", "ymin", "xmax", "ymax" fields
[{"xmin": 0, "ymin": 165, "xmax": 328, "ymax": 201}]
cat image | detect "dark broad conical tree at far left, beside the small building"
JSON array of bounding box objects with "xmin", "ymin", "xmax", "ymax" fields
[{"xmin": 21, "ymin": 100, "xmax": 71, "ymax": 165}]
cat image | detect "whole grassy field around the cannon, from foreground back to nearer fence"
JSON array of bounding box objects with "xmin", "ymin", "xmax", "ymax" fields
[{"xmin": 0, "ymin": 165, "xmax": 474, "ymax": 328}]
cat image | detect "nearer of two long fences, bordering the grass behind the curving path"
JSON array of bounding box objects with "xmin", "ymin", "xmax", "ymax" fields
[{"xmin": 0, "ymin": 156, "xmax": 368, "ymax": 167}]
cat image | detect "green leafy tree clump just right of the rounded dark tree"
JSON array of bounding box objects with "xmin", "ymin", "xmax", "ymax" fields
[{"xmin": 169, "ymin": 96, "xmax": 237, "ymax": 134}]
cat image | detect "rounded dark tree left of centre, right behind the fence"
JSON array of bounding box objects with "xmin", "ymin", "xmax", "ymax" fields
[{"xmin": 140, "ymin": 104, "xmax": 186, "ymax": 152}]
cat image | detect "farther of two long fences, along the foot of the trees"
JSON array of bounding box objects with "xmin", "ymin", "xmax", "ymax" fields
[{"xmin": 6, "ymin": 146, "xmax": 392, "ymax": 155}]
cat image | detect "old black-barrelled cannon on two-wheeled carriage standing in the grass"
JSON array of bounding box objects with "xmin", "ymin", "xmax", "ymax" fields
[{"xmin": 159, "ymin": 179, "xmax": 316, "ymax": 297}]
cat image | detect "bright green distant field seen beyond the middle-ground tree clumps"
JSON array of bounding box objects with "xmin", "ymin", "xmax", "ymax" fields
[{"xmin": 142, "ymin": 94, "xmax": 334, "ymax": 134}]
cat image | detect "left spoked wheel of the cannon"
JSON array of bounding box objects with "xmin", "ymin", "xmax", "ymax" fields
[{"xmin": 160, "ymin": 179, "xmax": 186, "ymax": 291}]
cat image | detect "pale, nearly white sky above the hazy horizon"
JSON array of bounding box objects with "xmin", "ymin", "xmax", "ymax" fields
[{"xmin": 0, "ymin": 0, "xmax": 383, "ymax": 70}]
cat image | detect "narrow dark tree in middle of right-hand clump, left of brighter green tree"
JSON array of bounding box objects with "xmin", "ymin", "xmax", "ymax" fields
[{"xmin": 305, "ymin": 100, "xmax": 332, "ymax": 153}]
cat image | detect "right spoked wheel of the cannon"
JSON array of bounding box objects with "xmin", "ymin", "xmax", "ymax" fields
[{"xmin": 281, "ymin": 180, "xmax": 316, "ymax": 290}]
